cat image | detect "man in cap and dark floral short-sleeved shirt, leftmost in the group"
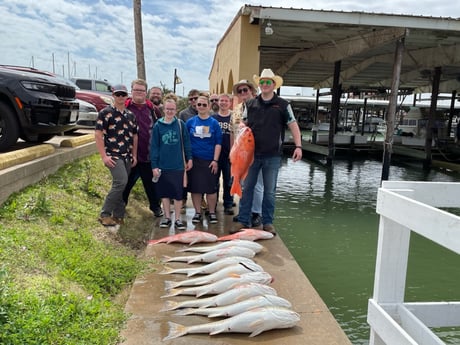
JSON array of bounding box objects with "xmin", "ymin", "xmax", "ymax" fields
[{"xmin": 94, "ymin": 85, "xmax": 139, "ymax": 226}]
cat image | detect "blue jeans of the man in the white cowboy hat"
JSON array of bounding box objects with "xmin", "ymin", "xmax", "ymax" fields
[{"xmin": 238, "ymin": 155, "xmax": 281, "ymax": 226}]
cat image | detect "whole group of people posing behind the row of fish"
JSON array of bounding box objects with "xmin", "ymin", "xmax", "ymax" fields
[{"xmin": 95, "ymin": 69, "xmax": 302, "ymax": 233}]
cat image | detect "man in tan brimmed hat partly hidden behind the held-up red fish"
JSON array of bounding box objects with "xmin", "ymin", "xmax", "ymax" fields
[{"xmin": 232, "ymin": 79, "xmax": 264, "ymax": 228}]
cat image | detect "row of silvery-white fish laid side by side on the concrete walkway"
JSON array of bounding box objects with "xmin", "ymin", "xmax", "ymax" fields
[{"xmin": 159, "ymin": 236, "xmax": 300, "ymax": 341}]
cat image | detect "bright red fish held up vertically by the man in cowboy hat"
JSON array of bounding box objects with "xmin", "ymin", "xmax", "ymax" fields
[{"xmin": 230, "ymin": 127, "xmax": 255, "ymax": 197}]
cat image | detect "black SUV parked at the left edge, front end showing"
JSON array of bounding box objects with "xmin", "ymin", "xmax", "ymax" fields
[{"xmin": 0, "ymin": 65, "xmax": 78, "ymax": 151}]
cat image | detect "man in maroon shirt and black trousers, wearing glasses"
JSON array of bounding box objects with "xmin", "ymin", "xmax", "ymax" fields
[{"xmin": 123, "ymin": 79, "xmax": 163, "ymax": 218}]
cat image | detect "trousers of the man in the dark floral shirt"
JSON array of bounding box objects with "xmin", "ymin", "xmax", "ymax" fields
[{"xmin": 101, "ymin": 159, "xmax": 131, "ymax": 218}]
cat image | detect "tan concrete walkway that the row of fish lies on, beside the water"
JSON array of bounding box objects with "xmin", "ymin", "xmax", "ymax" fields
[{"xmin": 118, "ymin": 222, "xmax": 351, "ymax": 345}]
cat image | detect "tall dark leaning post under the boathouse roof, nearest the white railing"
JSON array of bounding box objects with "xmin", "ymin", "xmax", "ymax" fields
[{"xmin": 381, "ymin": 36, "xmax": 405, "ymax": 181}]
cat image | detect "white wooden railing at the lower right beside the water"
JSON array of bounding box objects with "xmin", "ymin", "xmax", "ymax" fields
[{"xmin": 367, "ymin": 181, "xmax": 460, "ymax": 345}]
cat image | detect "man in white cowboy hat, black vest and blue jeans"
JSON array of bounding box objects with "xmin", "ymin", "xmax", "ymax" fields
[{"xmin": 231, "ymin": 68, "xmax": 302, "ymax": 233}]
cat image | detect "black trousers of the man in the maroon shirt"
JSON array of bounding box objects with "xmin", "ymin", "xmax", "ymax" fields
[{"xmin": 123, "ymin": 162, "xmax": 161, "ymax": 212}]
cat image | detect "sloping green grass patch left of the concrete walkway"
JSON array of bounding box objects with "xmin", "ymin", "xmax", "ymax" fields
[{"xmin": 0, "ymin": 154, "xmax": 152, "ymax": 345}]
